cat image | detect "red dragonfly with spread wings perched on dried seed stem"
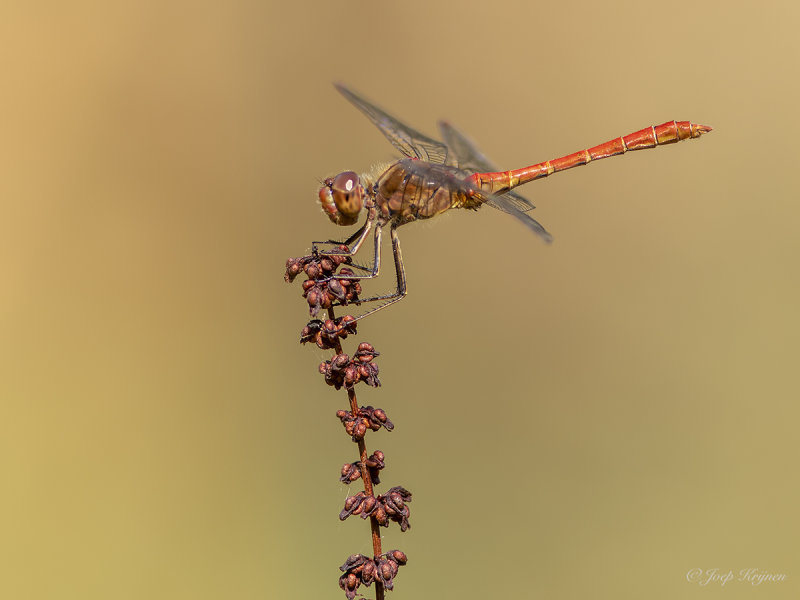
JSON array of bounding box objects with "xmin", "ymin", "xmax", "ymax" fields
[{"xmin": 315, "ymin": 84, "xmax": 711, "ymax": 319}]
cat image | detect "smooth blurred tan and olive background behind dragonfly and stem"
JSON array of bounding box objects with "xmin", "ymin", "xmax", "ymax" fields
[{"xmin": 0, "ymin": 0, "xmax": 800, "ymax": 600}]
